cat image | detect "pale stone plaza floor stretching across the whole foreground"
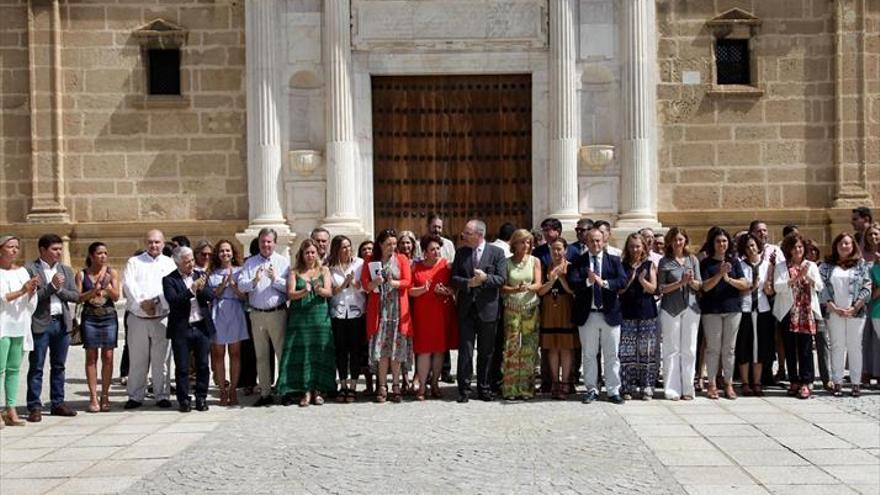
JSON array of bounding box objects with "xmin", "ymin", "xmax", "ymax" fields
[{"xmin": 0, "ymin": 349, "xmax": 880, "ymax": 495}]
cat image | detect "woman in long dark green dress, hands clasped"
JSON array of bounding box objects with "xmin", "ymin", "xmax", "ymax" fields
[{"xmin": 278, "ymin": 239, "xmax": 336, "ymax": 407}]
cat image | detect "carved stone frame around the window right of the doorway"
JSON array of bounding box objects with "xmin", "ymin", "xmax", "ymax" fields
[{"xmin": 706, "ymin": 8, "xmax": 764, "ymax": 98}]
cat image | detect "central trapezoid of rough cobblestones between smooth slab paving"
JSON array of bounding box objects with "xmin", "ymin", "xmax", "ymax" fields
[{"xmin": 132, "ymin": 398, "xmax": 683, "ymax": 494}]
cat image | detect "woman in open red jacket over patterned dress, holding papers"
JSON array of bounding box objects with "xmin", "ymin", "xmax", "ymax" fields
[{"xmin": 361, "ymin": 229, "xmax": 412, "ymax": 402}]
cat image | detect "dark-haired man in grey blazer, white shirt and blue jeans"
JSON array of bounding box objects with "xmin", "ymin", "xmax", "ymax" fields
[{"xmin": 25, "ymin": 234, "xmax": 79, "ymax": 423}]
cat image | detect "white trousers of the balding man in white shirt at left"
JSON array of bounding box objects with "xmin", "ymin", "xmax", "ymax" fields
[{"xmin": 126, "ymin": 313, "xmax": 171, "ymax": 402}]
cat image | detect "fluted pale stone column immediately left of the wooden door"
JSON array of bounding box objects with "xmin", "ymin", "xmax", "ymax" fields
[{"xmin": 323, "ymin": 0, "xmax": 364, "ymax": 237}]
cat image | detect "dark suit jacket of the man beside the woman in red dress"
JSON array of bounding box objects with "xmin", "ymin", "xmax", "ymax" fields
[{"xmin": 451, "ymin": 242, "xmax": 507, "ymax": 322}]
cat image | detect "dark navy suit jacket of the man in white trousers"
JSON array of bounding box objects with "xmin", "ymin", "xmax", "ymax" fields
[{"xmin": 568, "ymin": 251, "xmax": 627, "ymax": 326}]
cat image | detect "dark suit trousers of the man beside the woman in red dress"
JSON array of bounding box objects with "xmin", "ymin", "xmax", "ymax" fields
[{"xmin": 458, "ymin": 308, "xmax": 500, "ymax": 394}]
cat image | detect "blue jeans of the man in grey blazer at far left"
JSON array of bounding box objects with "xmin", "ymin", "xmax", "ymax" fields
[{"xmin": 27, "ymin": 317, "xmax": 70, "ymax": 411}]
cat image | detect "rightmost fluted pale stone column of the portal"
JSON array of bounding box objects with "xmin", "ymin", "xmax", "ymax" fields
[{"xmin": 617, "ymin": 0, "xmax": 659, "ymax": 229}]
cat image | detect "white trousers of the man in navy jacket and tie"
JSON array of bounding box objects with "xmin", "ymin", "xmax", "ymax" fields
[{"xmin": 578, "ymin": 311, "xmax": 620, "ymax": 397}]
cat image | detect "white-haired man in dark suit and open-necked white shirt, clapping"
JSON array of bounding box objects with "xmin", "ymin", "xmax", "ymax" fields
[{"xmin": 162, "ymin": 246, "xmax": 214, "ymax": 412}]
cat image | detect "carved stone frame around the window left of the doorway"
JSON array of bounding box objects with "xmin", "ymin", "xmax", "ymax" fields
[{"xmin": 132, "ymin": 18, "xmax": 190, "ymax": 108}]
